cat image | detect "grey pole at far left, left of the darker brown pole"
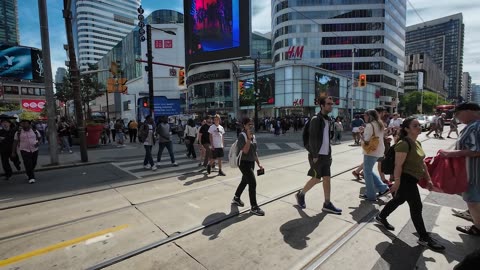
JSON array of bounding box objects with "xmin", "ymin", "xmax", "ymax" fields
[{"xmin": 38, "ymin": 0, "xmax": 58, "ymax": 165}]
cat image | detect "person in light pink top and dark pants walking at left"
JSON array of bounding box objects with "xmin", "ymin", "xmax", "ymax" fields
[{"xmin": 12, "ymin": 119, "xmax": 41, "ymax": 184}]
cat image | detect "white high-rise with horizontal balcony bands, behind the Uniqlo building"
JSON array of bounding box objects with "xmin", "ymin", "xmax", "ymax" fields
[{"xmin": 71, "ymin": 0, "xmax": 141, "ymax": 70}]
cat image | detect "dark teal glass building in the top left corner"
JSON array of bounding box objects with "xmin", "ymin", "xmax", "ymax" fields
[{"xmin": 0, "ymin": 0, "xmax": 20, "ymax": 45}]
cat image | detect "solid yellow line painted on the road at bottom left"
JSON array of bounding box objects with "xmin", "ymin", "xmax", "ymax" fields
[{"xmin": 0, "ymin": 224, "xmax": 128, "ymax": 267}]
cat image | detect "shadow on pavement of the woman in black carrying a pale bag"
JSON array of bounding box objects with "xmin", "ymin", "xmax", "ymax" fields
[{"xmin": 202, "ymin": 204, "xmax": 252, "ymax": 240}]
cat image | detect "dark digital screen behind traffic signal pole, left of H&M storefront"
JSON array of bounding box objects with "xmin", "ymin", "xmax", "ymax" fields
[{"xmin": 238, "ymin": 74, "xmax": 275, "ymax": 106}]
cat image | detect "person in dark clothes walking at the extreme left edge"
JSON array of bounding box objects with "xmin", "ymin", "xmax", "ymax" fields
[{"xmin": 0, "ymin": 118, "xmax": 21, "ymax": 180}]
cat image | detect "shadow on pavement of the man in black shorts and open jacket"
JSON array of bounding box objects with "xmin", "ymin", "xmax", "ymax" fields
[{"xmin": 280, "ymin": 206, "xmax": 327, "ymax": 250}]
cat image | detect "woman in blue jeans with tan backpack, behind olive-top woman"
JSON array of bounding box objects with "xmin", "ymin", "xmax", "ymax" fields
[{"xmin": 360, "ymin": 110, "xmax": 389, "ymax": 201}]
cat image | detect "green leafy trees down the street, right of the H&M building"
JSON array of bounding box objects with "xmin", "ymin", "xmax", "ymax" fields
[{"xmin": 400, "ymin": 91, "xmax": 448, "ymax": 115}]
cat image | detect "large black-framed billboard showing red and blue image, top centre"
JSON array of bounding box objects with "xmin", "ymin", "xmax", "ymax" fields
[{"xmin": 183, "ymin": 0, "xmax": 251, "ymax": 70}]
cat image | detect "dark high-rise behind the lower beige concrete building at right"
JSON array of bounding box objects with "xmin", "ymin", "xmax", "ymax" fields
[{"xmin": 405, "ymin": 13, "xmax": 465, "ymax": 99}]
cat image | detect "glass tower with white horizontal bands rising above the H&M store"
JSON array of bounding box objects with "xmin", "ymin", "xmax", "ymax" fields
[{"xmin": 272, "ymin": 0, "xmax": 406, "ymax": 96}]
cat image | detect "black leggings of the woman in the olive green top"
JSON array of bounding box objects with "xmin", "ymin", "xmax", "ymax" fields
[{"xmin": 380, "ymin": 173, "xmax": 428, "ymax": 237}]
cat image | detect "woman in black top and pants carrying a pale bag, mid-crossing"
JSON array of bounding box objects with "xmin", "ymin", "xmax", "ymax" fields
[{"xmin": 232, "ymin": 118, "xmax": 265, "ymax": 216}]
